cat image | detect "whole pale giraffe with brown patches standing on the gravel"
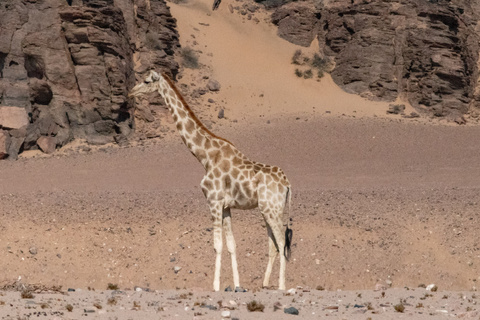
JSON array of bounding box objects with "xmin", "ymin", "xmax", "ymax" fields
[{"xmin": 129, "ymin": 70, "xmax": 293, "ymax": 291}]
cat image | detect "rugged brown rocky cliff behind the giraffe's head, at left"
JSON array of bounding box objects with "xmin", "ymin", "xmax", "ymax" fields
[{"xmin": 0, "ymin": 0, "xmax": 179, "ymax": 158}]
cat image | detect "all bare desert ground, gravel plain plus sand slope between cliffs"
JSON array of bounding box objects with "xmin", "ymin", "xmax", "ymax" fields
[{"xmin": 0, "ymin": 1, "xmax": 480, "ymax": 319}]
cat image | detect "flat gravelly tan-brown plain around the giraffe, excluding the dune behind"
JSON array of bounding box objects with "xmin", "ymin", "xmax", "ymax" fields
[{"xmin": 0, "ymin": 114, "xmax": 480, "ymax": 319}]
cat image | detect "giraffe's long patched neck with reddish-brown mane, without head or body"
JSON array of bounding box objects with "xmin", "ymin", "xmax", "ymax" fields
[{"xmin": 158, "ymin": 75, "xmax": 218, "ymax": 168}]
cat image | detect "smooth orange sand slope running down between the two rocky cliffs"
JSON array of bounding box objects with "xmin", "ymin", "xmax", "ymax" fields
[{"xmin": 166, "ymin": 0, "xmax": 408, "ymax": 121}]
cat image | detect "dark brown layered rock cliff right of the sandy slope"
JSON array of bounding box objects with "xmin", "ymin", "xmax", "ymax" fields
[{"xmin": 272, "ymin": 0, "xmax": 480, "ymax": 119}]
